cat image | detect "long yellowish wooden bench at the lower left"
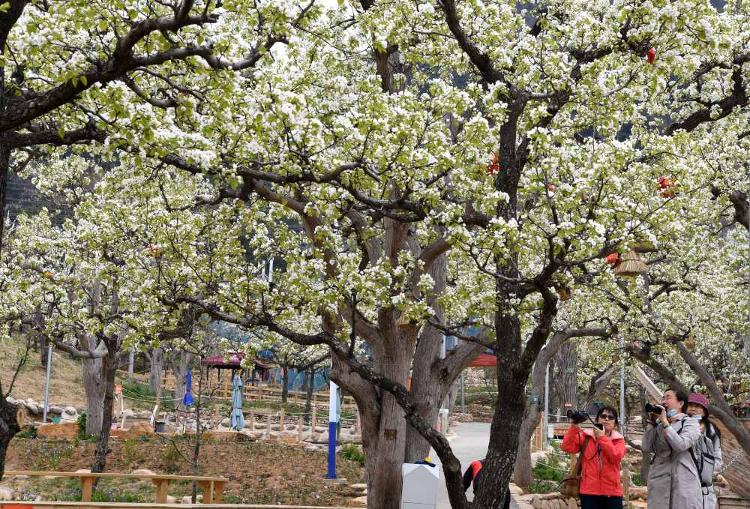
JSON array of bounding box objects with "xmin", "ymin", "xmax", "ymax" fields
[{"xmin": 5, "ymin": 470, "xmax": 229, "ymax": 504}]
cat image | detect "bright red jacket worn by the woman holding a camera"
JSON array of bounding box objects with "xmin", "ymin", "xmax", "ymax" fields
[{"xmin": 560, "ymin": 426, "xmax": 625, "ymax": 497}]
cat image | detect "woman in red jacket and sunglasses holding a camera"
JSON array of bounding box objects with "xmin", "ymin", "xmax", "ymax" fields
[{"xmin": 561, "ymin": 406, "xmax": 625, "ymax": 509}]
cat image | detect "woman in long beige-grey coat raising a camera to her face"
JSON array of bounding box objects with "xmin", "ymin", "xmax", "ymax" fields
[{"xmin": 642, "ymin": 390, "xmax": 703, "ymax": 509}]
